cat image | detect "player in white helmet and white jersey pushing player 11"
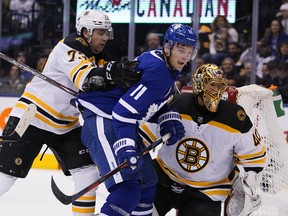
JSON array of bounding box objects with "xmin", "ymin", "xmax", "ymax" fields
[{"xmin": 0, "ymin": 10, "xmax": 140, "ymax": 216}]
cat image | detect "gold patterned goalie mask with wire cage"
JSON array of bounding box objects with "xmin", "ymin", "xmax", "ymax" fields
[{"xmin": 192, "ymin": 64, "xmax": 227, "ymax": 112}]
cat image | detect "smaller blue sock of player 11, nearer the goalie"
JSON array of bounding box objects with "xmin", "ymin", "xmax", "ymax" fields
[{"xmin": 131, "ymin": 185, "xmax": 157, "ymax": 216}]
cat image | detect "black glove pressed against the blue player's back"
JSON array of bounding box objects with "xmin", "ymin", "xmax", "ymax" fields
[{"xmin": 104, "ymin": 61, "xmax": 142, "ymax": 89}]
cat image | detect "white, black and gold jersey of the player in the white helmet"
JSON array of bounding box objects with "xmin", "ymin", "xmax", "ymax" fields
[{"xmin": 11, "ymin": 33, "xmax": 108, "ymax": 134}]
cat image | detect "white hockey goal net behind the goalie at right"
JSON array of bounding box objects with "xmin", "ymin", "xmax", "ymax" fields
[{"xmin": 237, "ymin": 85, "xmax": 288, "ymax": 216}]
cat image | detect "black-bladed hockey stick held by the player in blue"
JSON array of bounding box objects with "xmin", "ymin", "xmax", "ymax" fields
[{"xmin": 51, "ymin": 133, "xmax": 170, "ymax": 205}]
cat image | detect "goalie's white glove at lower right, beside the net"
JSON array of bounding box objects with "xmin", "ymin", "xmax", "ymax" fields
[{"xmin": 226, "ymin": 166, "xmax": 261, "ymax": 216}]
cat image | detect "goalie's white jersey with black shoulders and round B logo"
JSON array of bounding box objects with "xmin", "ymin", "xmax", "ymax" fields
[{"xmin": 140, "ymin": 94, "xmax": 265, "ymax": 201}]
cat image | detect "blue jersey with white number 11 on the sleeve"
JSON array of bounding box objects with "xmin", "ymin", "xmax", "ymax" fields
[{"xmin": 77, "ymin": 50, "xmax": 179, "ymax": 140}]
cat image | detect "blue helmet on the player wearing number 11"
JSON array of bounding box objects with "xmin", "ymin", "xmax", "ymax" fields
[{"xmin": 163, "ymin": 24, "xmax": 198, "ymax": 60}]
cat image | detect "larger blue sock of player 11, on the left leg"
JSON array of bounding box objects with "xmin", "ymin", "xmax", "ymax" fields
[{"xmin": 100, "ymin": 180, "xmax": 141, "ymax": 216}]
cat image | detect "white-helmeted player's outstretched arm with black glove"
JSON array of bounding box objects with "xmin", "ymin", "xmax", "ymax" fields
[{"xmin": 53, "ymin": 44, "xmax": 141, "ymax": 91}]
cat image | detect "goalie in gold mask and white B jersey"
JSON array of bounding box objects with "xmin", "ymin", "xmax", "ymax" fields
[{"xmin": 140, "ymin": 64, "xmax": 265, "ymax": 216}]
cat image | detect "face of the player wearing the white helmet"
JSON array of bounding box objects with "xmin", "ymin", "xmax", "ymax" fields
[{"xmin": 90, "ymin": 29, "xmax": 109, "ymax": 53}]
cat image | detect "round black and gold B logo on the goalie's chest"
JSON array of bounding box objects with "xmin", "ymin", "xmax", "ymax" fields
[{"xmin": 176, "ymin": 138, "xmax": 209, "ymax": 173}]
